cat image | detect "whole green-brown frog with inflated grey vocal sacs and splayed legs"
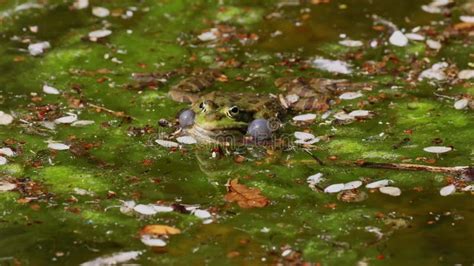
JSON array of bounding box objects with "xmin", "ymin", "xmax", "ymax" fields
[{"xmin": 169, "ymin": 70, "xmax": 367, "ymax": 143}]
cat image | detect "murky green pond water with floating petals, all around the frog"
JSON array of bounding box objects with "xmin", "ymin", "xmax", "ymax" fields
[{"xmin": 0, "ymin": 0, "xmax": 474, "ymax": 265}]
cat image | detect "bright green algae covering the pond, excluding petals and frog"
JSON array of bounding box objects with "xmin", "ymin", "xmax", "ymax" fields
[{"xmin": 0, "ymin": 0, "xmax": 474, "ymax": 265}]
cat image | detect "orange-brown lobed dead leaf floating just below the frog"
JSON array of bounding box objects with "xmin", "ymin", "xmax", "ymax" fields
[{"xmin": 224, "ymin": 178, "xmax": 269, "ymax": 208}]
